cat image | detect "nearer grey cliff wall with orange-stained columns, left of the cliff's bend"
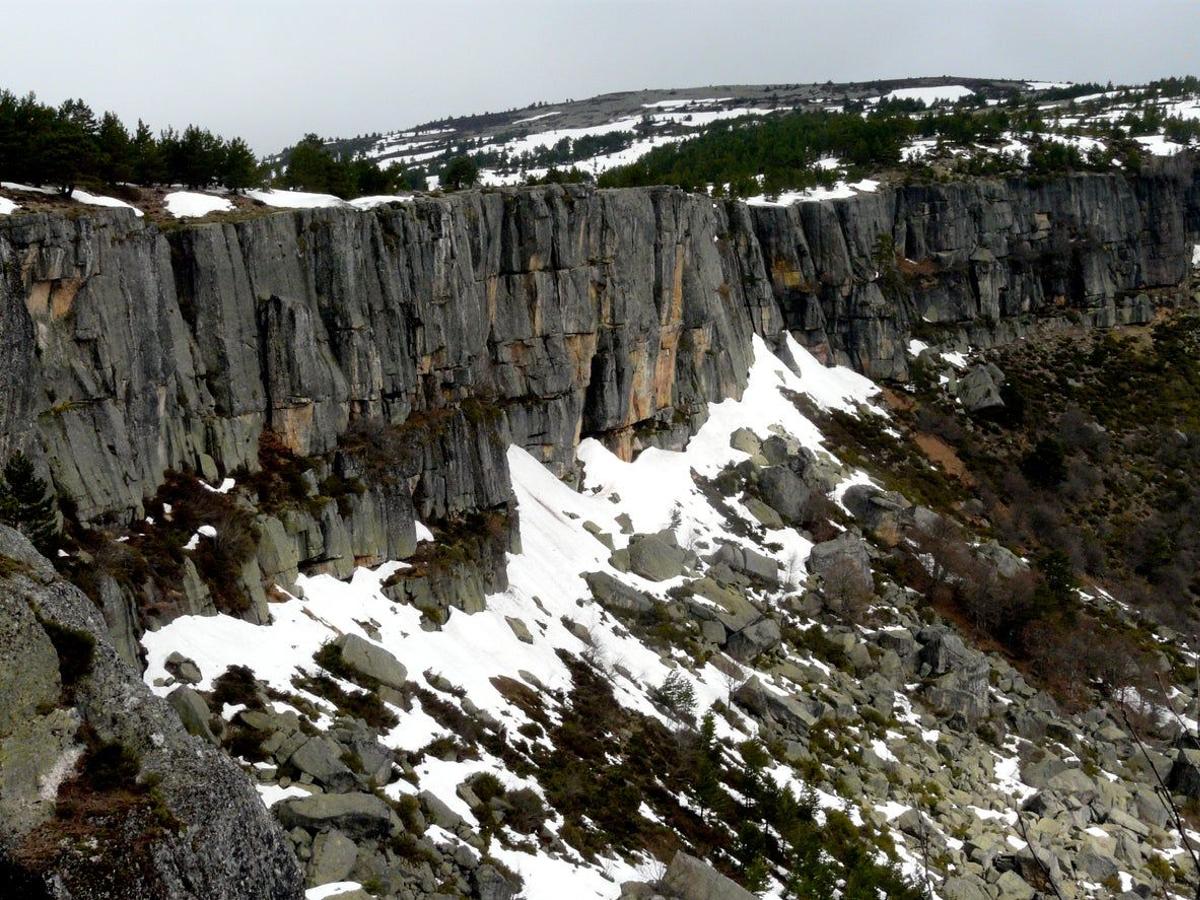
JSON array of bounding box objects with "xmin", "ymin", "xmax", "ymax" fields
[{"xmin": 0, "ymin": 188, "xmax": 774, "ymax": 528}]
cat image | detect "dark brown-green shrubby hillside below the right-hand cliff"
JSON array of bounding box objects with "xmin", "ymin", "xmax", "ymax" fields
[{"xmin": 809, "ymin": 314, "xmax": 1200, "ymax": 704}]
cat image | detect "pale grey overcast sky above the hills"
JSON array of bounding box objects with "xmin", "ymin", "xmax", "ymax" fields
[{"xmin": 0, "ymin": 0, "xmax": 1200, "ymax": 152}]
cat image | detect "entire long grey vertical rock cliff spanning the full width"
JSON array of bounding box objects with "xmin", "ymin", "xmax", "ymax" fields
[{"xmin": 0, "ymin": 162, "xmax": 1200, "ymax": 628}]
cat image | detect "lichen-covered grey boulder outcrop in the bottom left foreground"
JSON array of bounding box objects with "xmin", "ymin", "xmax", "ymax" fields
[{"xmin": 0, "ymin": 527, "xmax": 302, "ymax": 900}]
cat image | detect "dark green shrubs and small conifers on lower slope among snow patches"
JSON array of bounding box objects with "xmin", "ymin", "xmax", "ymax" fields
[{"xmin": 498, "ymin": 654, "xmax": 922, "ymax": 900}]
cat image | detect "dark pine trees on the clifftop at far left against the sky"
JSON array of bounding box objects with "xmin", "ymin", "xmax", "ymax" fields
[{"xmin": 0, "ymin": 91, "xmax": 263, "ymax": 193}]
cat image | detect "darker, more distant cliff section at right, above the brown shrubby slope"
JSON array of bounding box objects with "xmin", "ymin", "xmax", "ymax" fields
[{"xmin": 751, "ymin": 157, "xmax": 1198, "ymax": 378}]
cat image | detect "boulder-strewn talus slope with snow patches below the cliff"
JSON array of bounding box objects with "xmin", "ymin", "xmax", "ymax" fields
[{"xmin": 117, "ymin": 343, "xmax": 1200, "ymax": 900}]
